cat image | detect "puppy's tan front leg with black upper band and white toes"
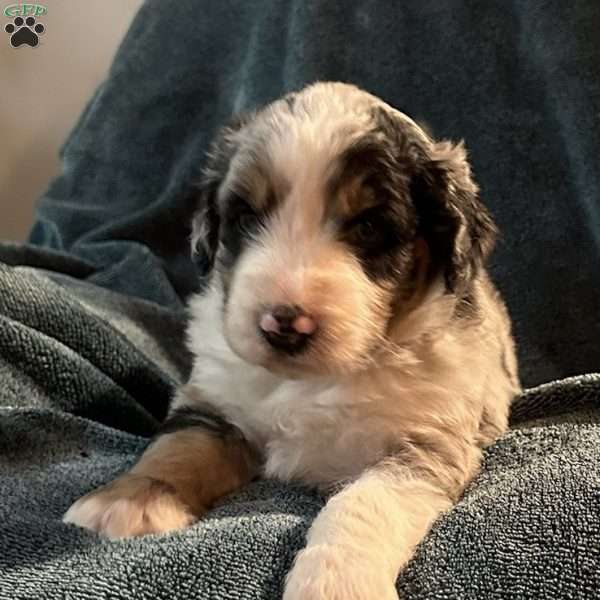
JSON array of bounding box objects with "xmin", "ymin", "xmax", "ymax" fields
[{"xmin": 63, "ymin": 394, "xmax": 257, "ymax": 538}]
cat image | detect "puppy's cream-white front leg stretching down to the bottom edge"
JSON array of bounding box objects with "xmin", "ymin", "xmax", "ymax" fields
[{"xmin": 284, "ymin": 461, "xmax": 452, "ymax": 600}]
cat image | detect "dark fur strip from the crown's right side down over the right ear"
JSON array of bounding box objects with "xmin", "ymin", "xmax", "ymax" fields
[{"xmin": 366, "ymin": 107, "xmax": 496, "ymax": 296}]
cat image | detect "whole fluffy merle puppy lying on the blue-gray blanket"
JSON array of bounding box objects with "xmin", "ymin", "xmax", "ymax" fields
[{"xmin": 65, "ymin": 83, "xmax": 519, "ymax": 600}]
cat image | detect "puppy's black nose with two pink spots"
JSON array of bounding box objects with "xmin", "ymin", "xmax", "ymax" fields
[{"xmin": 258, "ymin": 304, "xmax": 317, "ymax": 354}]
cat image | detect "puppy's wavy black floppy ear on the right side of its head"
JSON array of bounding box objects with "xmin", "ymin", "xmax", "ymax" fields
[{"xmin": 411, "ymin": 141, "xmax": 496, "ymax": 294}]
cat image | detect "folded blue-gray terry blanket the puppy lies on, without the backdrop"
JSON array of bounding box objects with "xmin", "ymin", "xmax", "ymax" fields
[{"xmin": 0, "ymin": 258, "xmax": 600, "ymax": 600}]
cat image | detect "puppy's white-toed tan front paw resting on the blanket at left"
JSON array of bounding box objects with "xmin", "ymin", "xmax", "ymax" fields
[{"xmin": 63, "ymin": 474, "xmax": 195, "ymax": 538}]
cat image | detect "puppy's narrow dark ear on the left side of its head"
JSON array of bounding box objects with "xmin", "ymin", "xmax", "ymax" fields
[{"xmin": 191, "ymin": 115, "xmax": 251, "ymax": 276}]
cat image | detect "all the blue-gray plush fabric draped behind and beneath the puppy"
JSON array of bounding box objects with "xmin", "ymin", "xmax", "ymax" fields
[{"xmin": 0, "ymin": 0, "xmax": 600, "ymax": 600}]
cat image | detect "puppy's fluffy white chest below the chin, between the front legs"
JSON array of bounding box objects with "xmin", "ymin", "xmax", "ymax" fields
[{"xmin": 194, "ymin": 358, "xmax": 394, "ymax": 485}]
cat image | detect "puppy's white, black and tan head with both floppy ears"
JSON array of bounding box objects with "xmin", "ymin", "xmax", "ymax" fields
[{"xmin": 193, "ymin": 83, "xmax": 494, "ymax": 376}]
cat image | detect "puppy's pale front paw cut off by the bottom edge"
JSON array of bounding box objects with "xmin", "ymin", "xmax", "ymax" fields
[{"xmin": 283, "ymin": 545, "xmax": 399, "ymax": 600}]
